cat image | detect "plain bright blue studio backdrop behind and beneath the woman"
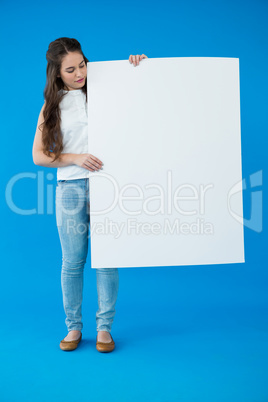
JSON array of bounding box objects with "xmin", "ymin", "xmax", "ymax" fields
[{"xmin": 0, "ymin": 0, "xmax": 268, "ymax": 402}]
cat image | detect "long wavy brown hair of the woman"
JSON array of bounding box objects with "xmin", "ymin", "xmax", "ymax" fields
[{"xmin": 39, "ymin": 38, "xmax": 89, "ymax": 162}]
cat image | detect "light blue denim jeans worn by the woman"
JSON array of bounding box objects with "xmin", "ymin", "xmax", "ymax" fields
[{"xmin": 56, "ymin": 178, "xmax": 119, "ymax": 333}]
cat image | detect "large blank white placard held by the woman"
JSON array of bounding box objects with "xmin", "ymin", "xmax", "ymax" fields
[{"xmin": 87, "ymin": 57, "xmax": 245, "ymax": 268}]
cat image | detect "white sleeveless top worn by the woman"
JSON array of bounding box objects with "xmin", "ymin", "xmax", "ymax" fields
[{"xmin": 57, "ymin": 89, "xmax": 89, "ymax": 180}]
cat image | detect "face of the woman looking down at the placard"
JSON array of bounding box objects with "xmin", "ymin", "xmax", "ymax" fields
[{"xmin": 60, "ymin": 52, "xmax": 87, "ymax": 91}]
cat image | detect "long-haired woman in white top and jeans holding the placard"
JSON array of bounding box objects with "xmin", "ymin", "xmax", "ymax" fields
[{"xmin": 33, "ymin": 38, "xmax": 147, "ymax": 352}]
